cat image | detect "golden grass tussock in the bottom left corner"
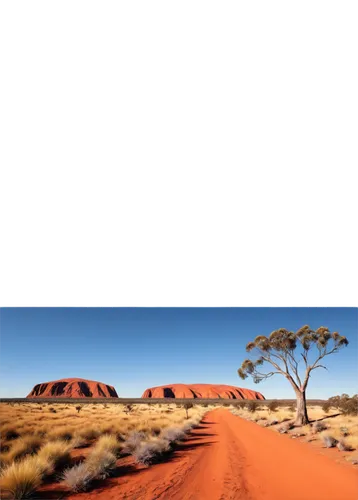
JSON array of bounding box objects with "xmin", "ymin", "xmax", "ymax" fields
[{"xmin": 0, "ymin": 457, "xmax": 41, "ymax": 500}]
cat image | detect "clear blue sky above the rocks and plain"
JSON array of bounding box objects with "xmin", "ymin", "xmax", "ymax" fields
[{"xmin": 0, "ymin": 306, "xmax": 358, "ymax": 399}]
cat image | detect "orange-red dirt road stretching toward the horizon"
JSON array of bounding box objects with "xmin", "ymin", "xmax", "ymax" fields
[{"xmin": 66, "ymin": 409, "xmax": 358, "ymax": 500}]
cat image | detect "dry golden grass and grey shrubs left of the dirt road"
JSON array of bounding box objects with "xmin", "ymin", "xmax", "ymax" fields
[{"xmin": 0, "ymin": 403, "xmax": 212, "ymax": 500}]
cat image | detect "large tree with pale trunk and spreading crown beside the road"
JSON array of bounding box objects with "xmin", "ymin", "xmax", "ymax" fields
[{"xmin": 238, "ymin": 325, "xmax": 348, "ymax": 425}]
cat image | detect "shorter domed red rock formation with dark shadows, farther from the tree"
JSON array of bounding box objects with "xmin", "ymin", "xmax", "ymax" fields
[{"xmin": 26, "ymin": 378, "xmax": 118, "ymax": 398}]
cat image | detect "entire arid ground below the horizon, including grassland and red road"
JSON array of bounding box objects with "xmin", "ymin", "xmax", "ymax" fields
[{"xmin": 0, "ymin": 399, "xmax": 358, "ymax": 500}]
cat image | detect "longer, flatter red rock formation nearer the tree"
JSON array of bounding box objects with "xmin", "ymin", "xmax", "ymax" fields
[{"xmin": 142, "ymin": 384, "xmax": 265, "ymax": 399}]
